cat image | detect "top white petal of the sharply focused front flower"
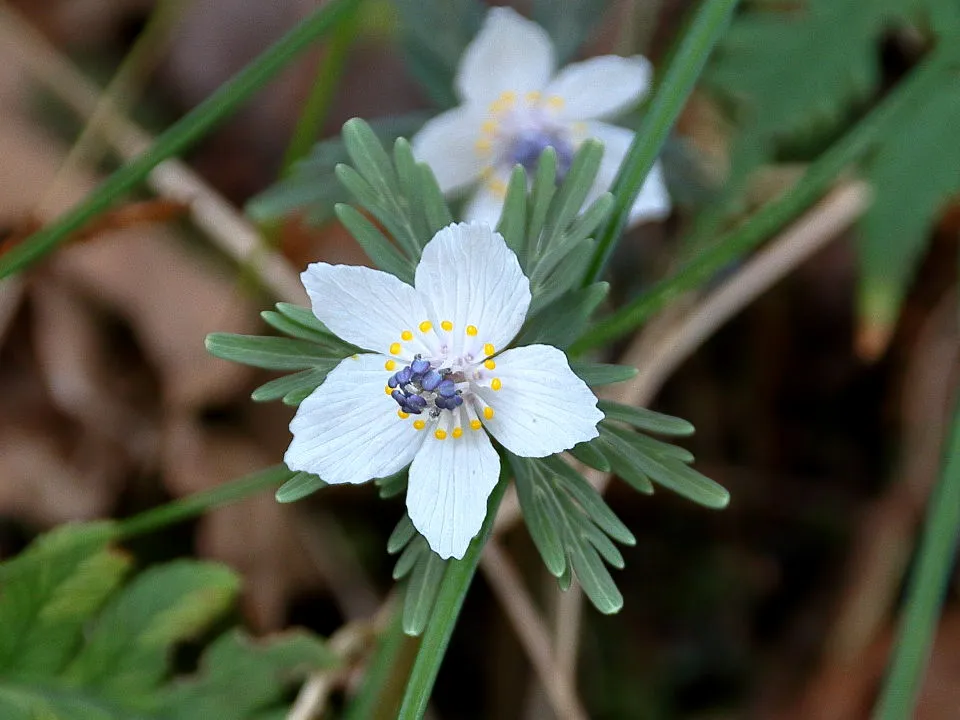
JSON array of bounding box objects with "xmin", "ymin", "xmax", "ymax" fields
[{"xmin": 415, "ymin": 223, "xmax": 530, "ymax": 354}]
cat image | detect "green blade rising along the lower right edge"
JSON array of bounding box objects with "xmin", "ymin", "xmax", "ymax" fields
[{"xmin": 874, "ymin": 398, "xmax": 960, "ymax": 720}]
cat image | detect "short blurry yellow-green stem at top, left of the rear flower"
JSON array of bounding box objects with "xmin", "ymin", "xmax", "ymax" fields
[{"xmin": 280, "ymin": 8, "xmax": 360, "ymax": 177}]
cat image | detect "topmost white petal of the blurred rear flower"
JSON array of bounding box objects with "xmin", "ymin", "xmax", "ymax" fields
[{"xmin": 456, "ymin": 7, "xmax": 555, "ymax": 106}]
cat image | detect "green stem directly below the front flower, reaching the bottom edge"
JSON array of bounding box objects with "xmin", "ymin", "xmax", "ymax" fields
[{"xmin": 397, "ymin": 476, "xmax": 508, "ymax": 720}]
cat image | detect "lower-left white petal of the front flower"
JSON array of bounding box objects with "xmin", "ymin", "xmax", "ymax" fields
[{"xmin": 283, "ymin": 355, "xmax": 424, "ymax": 485}]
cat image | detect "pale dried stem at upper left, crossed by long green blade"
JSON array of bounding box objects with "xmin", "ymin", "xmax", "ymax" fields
[{"xmin": 0, "ymin": 5, "xmax": 306, "ymax": 303}]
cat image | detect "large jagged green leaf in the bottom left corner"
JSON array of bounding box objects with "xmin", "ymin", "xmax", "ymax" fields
[{"xmin": 0, "ymin": 523, "xmax": 335, "ymax": 720}]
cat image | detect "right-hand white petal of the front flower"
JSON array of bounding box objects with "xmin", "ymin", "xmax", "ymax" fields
[{"xmin": 479, "ymin": 345, "xmax": 603, "ymax": 457}]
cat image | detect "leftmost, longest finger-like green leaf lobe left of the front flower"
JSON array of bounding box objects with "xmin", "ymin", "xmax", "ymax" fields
[{"xmin": 206, "ymin": 333, "xmax": 342, "ymax": 371}]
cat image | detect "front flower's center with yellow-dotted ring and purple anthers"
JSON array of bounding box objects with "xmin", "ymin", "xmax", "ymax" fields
[{"xmin": 384, "ymin": 320, "xmax": 503, "ymax": 440}]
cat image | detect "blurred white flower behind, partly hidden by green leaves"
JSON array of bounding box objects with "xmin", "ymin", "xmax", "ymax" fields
[{"xmin": 413, "ymin": 7, "xmax": 670, "ymax": 227}]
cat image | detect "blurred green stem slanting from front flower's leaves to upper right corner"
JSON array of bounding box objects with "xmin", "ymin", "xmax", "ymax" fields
[{"xmin": 569, "ymin": 49, "xmax": 953, "ymax": 355}]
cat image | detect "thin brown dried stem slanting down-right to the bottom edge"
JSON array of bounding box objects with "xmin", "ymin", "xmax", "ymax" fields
[{"xmin": 480, "ymin": 538, "xmax": 589, "ymax": 720}]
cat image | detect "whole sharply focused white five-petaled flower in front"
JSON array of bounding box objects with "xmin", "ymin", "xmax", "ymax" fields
[{"xmin": 284, "ymin": 224, "xmax": 603, "ymax": 558}]
